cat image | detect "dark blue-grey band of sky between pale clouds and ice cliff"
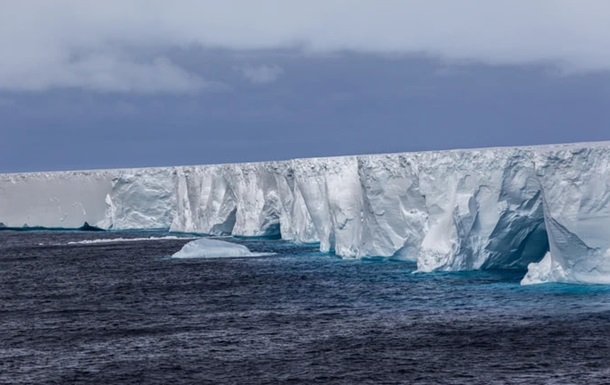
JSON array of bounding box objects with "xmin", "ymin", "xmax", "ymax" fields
[{"xmin": 0, "ymin": 49, "xmax": 610, "ymax": 172}]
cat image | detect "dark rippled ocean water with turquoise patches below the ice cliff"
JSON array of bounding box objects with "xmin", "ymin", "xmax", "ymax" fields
[{"xmin": 0, "ymin": 231, "xmax": 610, "ymax": 384}]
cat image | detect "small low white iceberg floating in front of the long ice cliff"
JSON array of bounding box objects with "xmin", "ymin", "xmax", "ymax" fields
[{"xmin": 172, "ymin": 238, "xmax": 270, "ymax": 258}]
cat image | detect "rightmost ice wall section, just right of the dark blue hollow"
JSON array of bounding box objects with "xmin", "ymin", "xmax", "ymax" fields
[{"xmin": 523, "ymin": 145, "xmax": 610, "ymax": 284}]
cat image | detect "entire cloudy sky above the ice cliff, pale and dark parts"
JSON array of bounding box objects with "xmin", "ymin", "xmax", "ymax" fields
[{"xmin": 0, "ymin": 0, "xmax": 610, "ymax": 172}]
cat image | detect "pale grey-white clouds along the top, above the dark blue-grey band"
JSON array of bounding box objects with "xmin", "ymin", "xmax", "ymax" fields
[{"xmin": 0, "ymin": 0, "xmax": 610, "ymax": 93}]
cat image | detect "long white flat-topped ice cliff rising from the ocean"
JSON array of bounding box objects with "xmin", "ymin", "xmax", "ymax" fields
[{"xmin": 0, "ymin": 143, "xmax": 610, "ymax": 283}]
